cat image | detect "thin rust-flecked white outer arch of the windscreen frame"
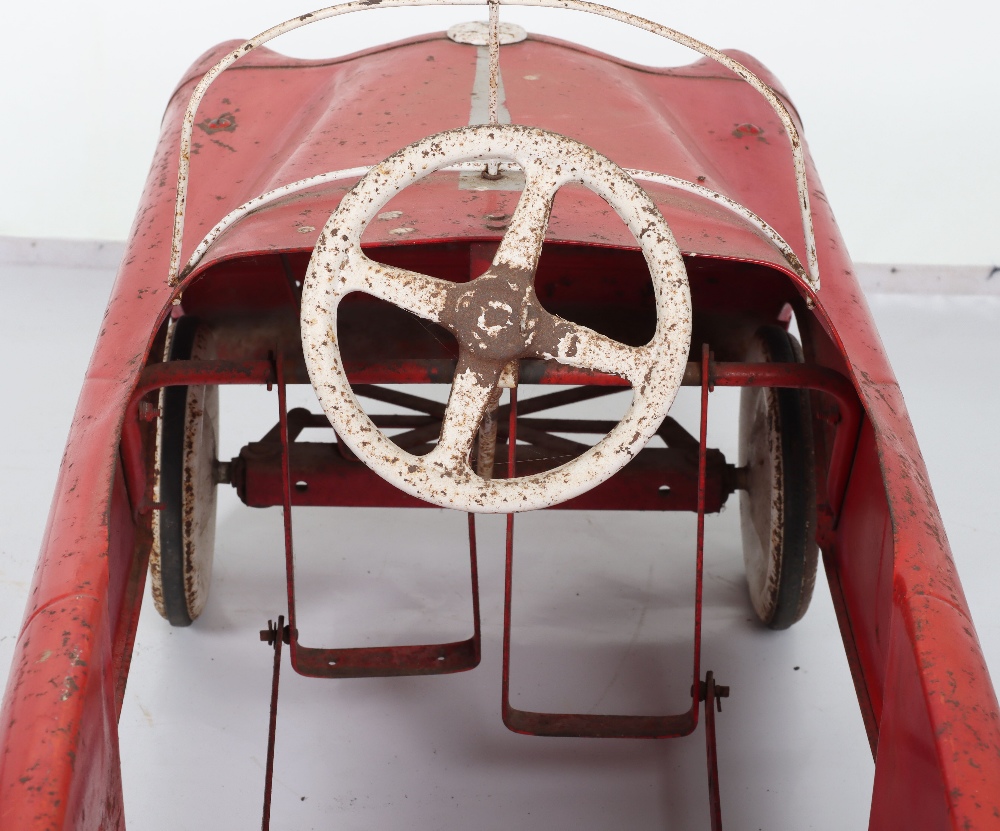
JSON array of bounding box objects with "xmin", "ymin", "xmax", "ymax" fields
[{"xmin": 167, "ymin": 0, "xmax": 820, "ymax": 291}]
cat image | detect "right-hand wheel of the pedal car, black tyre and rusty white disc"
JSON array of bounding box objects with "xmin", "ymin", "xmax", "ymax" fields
[{"xmin": 739, "ymin": 326, "xmax": 818, "ymax": 629}]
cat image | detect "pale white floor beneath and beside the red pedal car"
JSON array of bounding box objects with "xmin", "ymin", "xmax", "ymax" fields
[{"xmin": 0, "ymin": 255, "xmax": 1000, "ymax": 831}]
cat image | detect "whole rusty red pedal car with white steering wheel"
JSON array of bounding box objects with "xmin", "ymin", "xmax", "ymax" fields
[{"xmin": 0, "ymin": 0, "xmax": 1000, "ymax": 831}]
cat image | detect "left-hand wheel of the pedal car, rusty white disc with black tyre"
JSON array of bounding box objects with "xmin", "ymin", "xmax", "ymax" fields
[{"xmin": 149, "ymin": 317, "xmax": 219, "ymax": 626}]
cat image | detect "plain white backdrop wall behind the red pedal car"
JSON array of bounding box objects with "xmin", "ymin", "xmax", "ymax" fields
[{"xmin": 0, "ymin": 0, "xmax": 1000, "ymax": 264}]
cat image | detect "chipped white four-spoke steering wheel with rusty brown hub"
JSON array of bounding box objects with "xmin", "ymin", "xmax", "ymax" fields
[{"xmin": 301, "ymin": 125, "xmax": 691, "ymax": 513}]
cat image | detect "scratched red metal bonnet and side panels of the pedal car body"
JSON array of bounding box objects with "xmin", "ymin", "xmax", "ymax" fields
[{"xmin": 0, "ymin": 14, "xmax": 1000, "ymax": 829}]
